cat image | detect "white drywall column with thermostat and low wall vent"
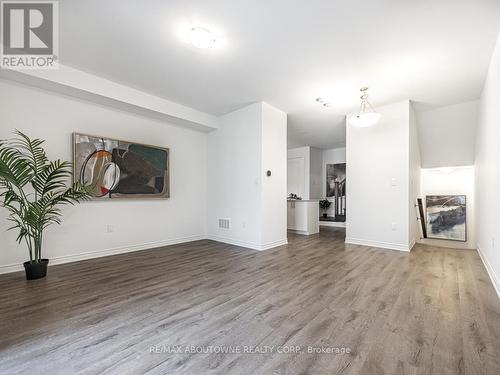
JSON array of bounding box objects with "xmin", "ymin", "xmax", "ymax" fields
[{"xmin": 207, "ymin": 103, "xmax": 287, "ymax": 250}]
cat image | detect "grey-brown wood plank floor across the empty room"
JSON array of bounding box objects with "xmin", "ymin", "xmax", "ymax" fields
[{"xmin": 0, "ymin": 228, "xmax": 500, "ymax": 375}]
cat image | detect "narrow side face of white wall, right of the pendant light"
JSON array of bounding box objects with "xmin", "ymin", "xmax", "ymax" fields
[{"xmin": 408, "ymin": 102, "xmax": 421, "ymax": 249}]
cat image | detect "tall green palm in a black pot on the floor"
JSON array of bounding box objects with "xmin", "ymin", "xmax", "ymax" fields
[{"xmin": 0, "ymin": 131, "xmax": 89, "ymax": 280}]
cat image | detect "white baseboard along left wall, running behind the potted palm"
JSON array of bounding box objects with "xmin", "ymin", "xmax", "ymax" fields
[{"xmin": 0, "ymin": 235, "xmax": 206, "ymax": 274}]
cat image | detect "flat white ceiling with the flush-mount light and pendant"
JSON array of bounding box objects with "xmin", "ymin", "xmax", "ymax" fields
[{"xmin": 60, "ymin": 0, "xmax": 500, "ymax": 148}]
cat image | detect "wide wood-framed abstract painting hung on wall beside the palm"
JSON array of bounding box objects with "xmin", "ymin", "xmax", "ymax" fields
[{"xmin": 73, "ymin": 133, "xmax": 170, "ymax": 199}]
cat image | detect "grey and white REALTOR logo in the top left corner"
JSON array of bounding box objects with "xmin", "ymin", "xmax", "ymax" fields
[{"xmin": 0, "ymin": 1, "xmax": 59, "ymax": 69}]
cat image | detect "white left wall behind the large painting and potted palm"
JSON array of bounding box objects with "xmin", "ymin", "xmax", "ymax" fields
[{"xmin": 0, "ymin": 80, "xmax": 207, "ymax": 271}]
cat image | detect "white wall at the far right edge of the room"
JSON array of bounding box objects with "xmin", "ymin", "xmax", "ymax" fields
[{"xmin": 475, "ymin": 33, "xmax": 500, "ymax": 296}]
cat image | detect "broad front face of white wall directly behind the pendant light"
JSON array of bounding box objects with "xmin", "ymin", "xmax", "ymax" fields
[{"xmin": 346, "ymin": 100, "xmax": 411, "ymax": 251}]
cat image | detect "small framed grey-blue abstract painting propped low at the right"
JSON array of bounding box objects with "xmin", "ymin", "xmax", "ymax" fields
[{"xmin": 425, "ymin": 195, "xmax": 467, "ymax": 242}]
